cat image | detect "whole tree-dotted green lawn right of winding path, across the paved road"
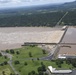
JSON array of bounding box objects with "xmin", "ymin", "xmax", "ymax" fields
[{"xmin": 2, "ymin": 46, "xmax": 76, "ymax": 75}]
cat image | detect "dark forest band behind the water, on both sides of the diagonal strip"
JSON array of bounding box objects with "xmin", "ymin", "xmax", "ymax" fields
[{"xmin": 0, "ymin": 10, "xmax": 76, "ymax": 27}]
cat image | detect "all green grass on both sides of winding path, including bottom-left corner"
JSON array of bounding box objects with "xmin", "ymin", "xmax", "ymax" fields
[{"xmin": 0, "ymin": 46, "xmax": 73, "ymax": 75}]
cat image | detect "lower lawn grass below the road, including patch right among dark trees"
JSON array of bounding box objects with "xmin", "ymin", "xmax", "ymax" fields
[{"xmin": 13, "ymin": 60, "xmax": 72, "ymax": 75}]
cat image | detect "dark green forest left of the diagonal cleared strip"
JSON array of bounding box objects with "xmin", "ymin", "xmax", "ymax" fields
[{"xmin": 0, "ymin": 11, "xmax": 65, "ymax": 27}]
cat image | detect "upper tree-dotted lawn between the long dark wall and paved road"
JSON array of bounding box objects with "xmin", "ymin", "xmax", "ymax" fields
[{"xmin": 10, "ymin": 46, "xmax": 48, "ymax": 61}]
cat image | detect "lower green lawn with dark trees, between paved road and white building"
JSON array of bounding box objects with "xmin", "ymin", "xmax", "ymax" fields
[{"xmin": 13, "ymin": 60, "xmax": 73, "ymax": 75}]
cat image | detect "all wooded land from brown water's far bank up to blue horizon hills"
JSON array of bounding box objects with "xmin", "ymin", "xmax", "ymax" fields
[{"xmin": 0, "ymin": 1, "xmax": 76, "ymax": 27}]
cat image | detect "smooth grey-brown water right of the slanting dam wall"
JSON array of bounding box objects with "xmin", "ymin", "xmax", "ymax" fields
[{"xmin": 62, "ymin": 28, "xmax": 76, "ymax": 43}]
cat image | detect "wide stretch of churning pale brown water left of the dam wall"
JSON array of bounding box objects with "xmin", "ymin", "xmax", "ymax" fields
[{"xmin": 0, "ymin": 27, "xmax": 64, "ymax": 50}]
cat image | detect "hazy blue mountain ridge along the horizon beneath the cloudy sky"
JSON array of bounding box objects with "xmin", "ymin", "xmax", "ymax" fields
[{"xmin": 0, "ymin": 1, "xmax": 76, "ymax": 13}]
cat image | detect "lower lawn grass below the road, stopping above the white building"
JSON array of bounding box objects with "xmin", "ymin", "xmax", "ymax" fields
[{"xmin": 13, "ymin": 60, "xmax": 56, "ymax": 75}]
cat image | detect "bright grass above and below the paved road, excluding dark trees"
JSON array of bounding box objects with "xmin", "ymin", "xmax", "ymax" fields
[{"xmin": 1, "ymin": 46, "xmax": 72, "ymax": 75}]
